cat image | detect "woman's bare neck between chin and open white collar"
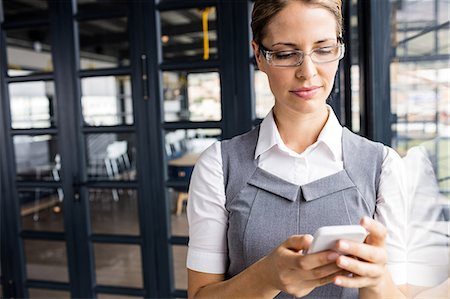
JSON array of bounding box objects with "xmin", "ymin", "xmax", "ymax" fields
[{"xmin": 273, "ymin": 105, "xmax": 329, "ymax": 153}]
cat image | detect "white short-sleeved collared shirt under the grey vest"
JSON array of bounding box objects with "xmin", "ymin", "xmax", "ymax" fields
[{"xmin": 187, "ymin": 106, "xmax": 407, "ymax": 284}]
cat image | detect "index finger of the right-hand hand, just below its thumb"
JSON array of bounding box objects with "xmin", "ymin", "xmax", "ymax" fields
[{"xmin": 336, "ymin": 240, "xmax": 387, "ymax": 265}]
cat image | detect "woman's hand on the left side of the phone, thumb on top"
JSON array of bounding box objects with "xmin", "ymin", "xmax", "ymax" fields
[{"xmin": 260, "ymin": 235, "xmax": 348, "ymax": 297}]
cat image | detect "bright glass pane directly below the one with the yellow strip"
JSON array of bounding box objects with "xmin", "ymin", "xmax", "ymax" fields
[{"xmin": 163, "ymin": 71, "xmax": 222, "ymax": 122}]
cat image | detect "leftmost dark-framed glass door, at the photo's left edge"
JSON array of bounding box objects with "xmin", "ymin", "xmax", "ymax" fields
[{"xmin": 0, "ymin": 1, "xmax": 70, "ymax": 298}]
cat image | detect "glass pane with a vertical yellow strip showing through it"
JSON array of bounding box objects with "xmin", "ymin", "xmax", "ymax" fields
[{"xmin": 160, "ymin": 7, "xmax": 218, "ymax": 61}]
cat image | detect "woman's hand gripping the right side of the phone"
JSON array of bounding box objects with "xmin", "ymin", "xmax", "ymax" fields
[{"xmin": 334, "ymin": 217, "xmax": 393, "ymax": 298}]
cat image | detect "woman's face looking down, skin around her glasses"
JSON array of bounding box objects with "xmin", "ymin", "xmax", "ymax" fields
[{"xmin": 252, "ymin": 1, "xmax": 339, "ymax": 114}]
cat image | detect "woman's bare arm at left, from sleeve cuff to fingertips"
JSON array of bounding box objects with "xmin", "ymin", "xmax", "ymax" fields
[{"xmin": 188, "ymin": 235, "xmax": 344, "ymax": 298}]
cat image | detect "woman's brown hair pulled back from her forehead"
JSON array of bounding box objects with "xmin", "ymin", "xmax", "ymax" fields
[{"xmin": 252, "ymin": 0, "xmax": 343, "ymax": 44}]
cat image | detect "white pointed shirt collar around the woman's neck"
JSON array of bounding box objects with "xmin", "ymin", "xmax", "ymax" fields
[{"xmin": 255, "ymin": 105, "xmax": 342, "ymax": 161}]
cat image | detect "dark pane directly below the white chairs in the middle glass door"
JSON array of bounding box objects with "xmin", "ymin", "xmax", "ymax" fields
[{"xmin": 89, "ymin": 189, "xmax": 139, "ymax": 235}]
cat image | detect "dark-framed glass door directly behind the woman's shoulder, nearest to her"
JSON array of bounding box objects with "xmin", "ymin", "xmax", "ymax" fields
[{"xmin": 143, "ymin": 0, "xmax": 254, "ymax": 298}]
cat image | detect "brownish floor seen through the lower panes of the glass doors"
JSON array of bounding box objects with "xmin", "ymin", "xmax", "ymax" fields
[{"xmin": 16, "ymin": 190, "xmax": 188, "ymax": 299}]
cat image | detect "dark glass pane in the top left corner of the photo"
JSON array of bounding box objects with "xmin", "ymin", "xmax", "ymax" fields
[{"xmin": 2, "ymin": 0, "xmax": 48, "ymax": 21}]
